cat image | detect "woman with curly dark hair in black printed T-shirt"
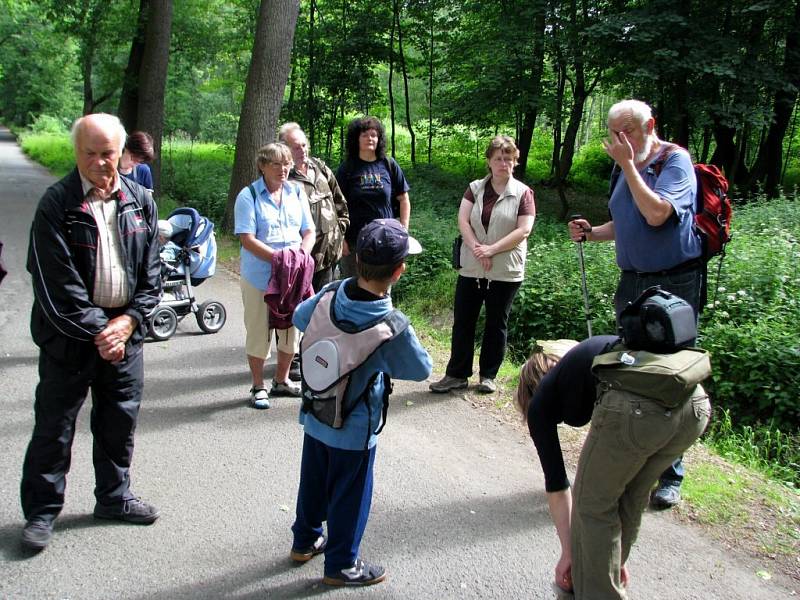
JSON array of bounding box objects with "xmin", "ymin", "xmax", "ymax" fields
[{"xmin": 336, "ymin": 117, "xmax": 411, "ymax": 277}]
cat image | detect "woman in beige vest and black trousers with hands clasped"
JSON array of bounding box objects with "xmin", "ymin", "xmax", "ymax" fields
[{"xmin": 430, "ymin": 135, "xmax": 536, "ymax": 393}]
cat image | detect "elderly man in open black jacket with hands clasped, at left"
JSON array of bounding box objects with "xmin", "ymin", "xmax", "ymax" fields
[{"xmin": 20, "ymin": 114, "xmax": 161, "ymax": 550}]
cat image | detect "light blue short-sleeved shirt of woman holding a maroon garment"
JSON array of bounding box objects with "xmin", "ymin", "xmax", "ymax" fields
[{"xmin": 233, "ymin": 177, "xmax": 314, "ymax": 291}]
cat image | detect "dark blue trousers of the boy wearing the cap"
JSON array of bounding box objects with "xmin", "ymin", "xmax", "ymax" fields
[{"xmin": 292, "ymin": 435, "xmax": 376, "ymax": 575}]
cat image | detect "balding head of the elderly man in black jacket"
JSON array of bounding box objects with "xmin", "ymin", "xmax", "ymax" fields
[{"xmin": 71, "ymin": 113, "xmax": 126, "ymax": 192}]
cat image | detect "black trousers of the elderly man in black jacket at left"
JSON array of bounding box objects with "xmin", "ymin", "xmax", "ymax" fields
[{"xmin": 20, "ymin": 342, "xmax": 144, "ymax": 522}]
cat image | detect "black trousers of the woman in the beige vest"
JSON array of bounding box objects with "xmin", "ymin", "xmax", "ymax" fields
[{"xmin": 447, "ymin": 275, "xmax": 522, "ymax": 379}]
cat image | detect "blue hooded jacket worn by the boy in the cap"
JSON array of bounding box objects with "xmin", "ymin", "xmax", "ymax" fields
[{"xmin": 292, "ymin": 282, "xmax": 432, "ymax": 450}]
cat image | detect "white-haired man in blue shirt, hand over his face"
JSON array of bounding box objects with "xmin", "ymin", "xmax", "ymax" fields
[{"xmin": 569, "ymin": 100, "xmax": 705, "ymax": 508}]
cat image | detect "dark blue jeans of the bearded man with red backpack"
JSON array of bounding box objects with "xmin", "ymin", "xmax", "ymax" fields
[{"xmin": 614, "ymin": 264, "xmax": 705, "ymax": 487}]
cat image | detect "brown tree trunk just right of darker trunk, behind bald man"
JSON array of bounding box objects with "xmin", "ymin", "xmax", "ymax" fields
[{"xmin": 137, "ymin": 0, "xmax": 172, "ymax": 194}]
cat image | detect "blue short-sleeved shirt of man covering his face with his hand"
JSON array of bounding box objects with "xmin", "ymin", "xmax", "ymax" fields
[{"xmin": 608, "ymin": 150, "xmax": 702, "ymax": 273}]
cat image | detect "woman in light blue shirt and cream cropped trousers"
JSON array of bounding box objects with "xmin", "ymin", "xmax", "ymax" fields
[{"xmin": 234, "ymin": 143, "xmax": 315, "ymax": 408}]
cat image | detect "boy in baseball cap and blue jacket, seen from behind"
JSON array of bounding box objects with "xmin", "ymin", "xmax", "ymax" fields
[{"xmin": 290, "ymin": 219, "xmax": 431, "ymax": 586}]
